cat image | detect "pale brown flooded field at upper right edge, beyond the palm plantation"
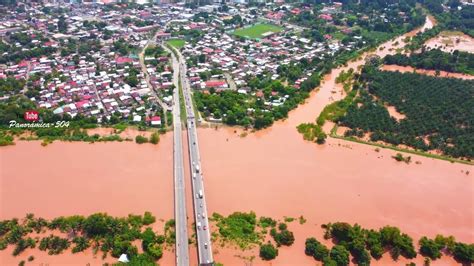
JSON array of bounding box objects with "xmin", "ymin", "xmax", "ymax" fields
[{"xmin": 425, "ymin": 31, "xmax": 474, "ymax": 53}]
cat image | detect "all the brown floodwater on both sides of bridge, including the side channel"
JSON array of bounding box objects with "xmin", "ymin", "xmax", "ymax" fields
[{"xmin": 0, "ymin": 15, "xmax": 474, "ymax": 265}]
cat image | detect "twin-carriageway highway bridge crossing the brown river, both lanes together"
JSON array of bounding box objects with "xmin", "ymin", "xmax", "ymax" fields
[{"xmin": 162, "ymin": 41, "xmax": 214, "ymax": 266}]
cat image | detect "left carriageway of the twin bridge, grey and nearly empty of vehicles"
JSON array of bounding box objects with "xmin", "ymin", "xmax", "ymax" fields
[{"xmin": 166, "ymin": 45, "xmax": 189, "ymax": 266}]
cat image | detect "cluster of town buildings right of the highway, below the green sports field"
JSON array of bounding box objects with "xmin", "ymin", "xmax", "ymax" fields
[{"xmin": 178, "ymin": 4, "xmax": 360, "ymax": 93}]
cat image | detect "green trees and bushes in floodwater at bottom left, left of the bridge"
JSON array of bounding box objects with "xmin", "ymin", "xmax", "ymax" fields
[{"xmin": 0, "ymin": 212, "xmax": 169, "ymax": 265}]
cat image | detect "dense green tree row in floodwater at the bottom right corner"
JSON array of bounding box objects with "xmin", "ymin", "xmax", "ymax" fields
[{"xmin": 305, "ymin": 222, "xmax": 474, "ymax": 265}]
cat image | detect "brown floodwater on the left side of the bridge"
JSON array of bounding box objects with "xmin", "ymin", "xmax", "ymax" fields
[{"xmin": 0, "ymin": 138, "xmax": 178, "ymax": 265}]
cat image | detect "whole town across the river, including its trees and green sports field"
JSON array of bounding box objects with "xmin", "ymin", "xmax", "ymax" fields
[{"xmin": 0, "ymin": 2, "xmax": 426, "ymax": 129}]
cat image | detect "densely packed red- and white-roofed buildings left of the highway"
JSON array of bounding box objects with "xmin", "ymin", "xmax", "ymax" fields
[{"xmin": 0, "ymin": 2, "xmax": 192, "ymax": 124}]
